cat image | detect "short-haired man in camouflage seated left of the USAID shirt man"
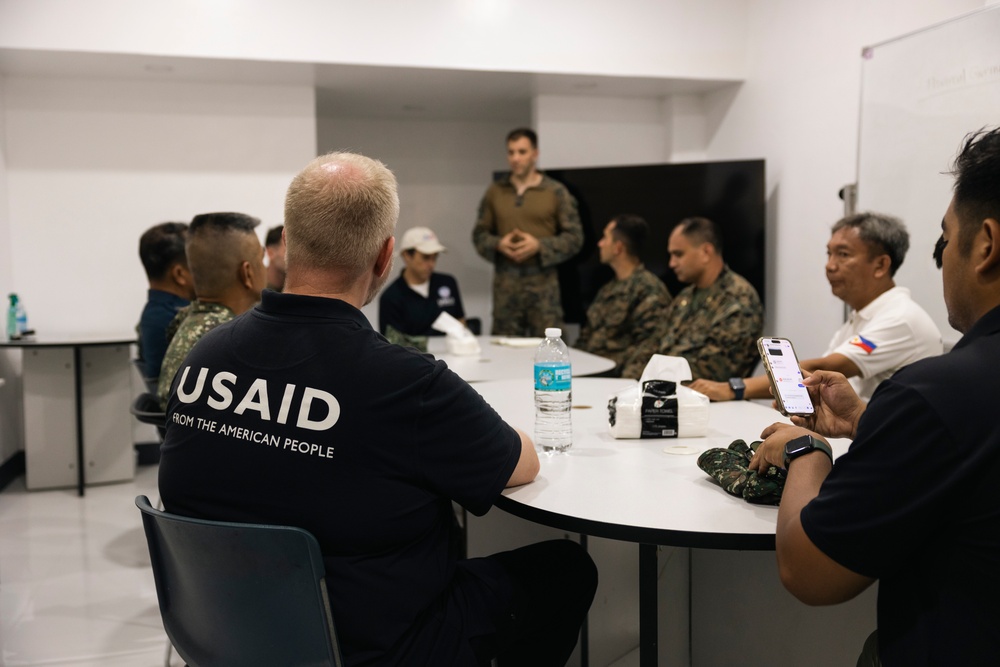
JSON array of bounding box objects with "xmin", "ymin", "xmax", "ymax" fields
[{"xmin": 157, "ymin": 213, "xmax": 267, "ymax": 410}]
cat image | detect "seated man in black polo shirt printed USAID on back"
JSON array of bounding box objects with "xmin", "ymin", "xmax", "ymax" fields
[{"xmin": 159, "ymin": 153, "xmax": 597, "ymax": 667}]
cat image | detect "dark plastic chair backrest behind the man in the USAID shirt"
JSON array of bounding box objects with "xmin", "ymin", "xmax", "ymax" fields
[{"xmin": 135, "ymin": 496, "xmax": 343, "ymax": 667}]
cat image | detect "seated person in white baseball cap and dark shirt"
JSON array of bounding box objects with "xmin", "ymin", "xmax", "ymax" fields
[{"xmin": 378, "ymin": 227, "xmax": 465, "ymax": 340}]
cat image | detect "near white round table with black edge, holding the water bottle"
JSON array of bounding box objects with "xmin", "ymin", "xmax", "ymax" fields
[{"xmin": 473, "ymin": 378, "xmax": 849, "ymax": 666}]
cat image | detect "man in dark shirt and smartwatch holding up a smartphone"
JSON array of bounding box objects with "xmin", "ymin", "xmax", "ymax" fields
[{"xmin": 751, "ymin": 128, "xmax": 1000, "ymax": 667}]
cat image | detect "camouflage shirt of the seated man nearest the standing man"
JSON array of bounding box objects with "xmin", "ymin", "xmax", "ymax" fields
[{"xmin": 576, "ymin": 264, "xmax": 670, "ymax": 375}]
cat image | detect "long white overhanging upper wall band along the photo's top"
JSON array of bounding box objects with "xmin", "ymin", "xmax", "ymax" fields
[{"xmin": 0, "ymin": 0, "xmax": 748, "ymax": 78}]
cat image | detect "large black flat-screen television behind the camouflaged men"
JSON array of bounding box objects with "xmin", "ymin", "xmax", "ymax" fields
[{"xmin": 536, "ymin": 160, "xmax": 766, "ymax": 323}]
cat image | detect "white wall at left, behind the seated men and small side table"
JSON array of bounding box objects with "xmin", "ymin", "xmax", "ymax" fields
[{"xmin": 6, "ymin": 78, "xmax": 316, "ymax": 336}]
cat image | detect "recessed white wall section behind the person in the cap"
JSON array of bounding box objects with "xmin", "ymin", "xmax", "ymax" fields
[{"xmin": 318, "ymin": 118, "xmax": 528, "ymax": 331}]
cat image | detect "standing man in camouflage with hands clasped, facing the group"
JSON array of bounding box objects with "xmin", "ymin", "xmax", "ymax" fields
[{"xmin": 472, "ymin": 128, "xmax": 583, "ymax": 336}]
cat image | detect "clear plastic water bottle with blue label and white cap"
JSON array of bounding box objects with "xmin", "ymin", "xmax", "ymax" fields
[{"xmin": 535, "ymin": 327, "xmax": 573, "ymax": 452}]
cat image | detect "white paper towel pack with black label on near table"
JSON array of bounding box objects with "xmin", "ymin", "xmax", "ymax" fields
[{"xmin": 608, "ymin": 380, "xmax": 709, "ymax": 438}]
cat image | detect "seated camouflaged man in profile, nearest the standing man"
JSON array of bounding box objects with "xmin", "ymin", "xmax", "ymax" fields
[{"xmin": 576, "ymin": 214, "xmax": 670, "ymax": 376}]
